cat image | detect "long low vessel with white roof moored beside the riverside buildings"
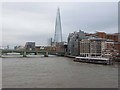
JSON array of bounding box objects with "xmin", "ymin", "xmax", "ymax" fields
[{"xmin": 74, "ymin": 57, "xmax": 113, "ymax": 65}]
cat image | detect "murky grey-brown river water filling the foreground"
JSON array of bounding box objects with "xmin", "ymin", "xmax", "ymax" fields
[{"xmin": 2, "ymin": 56, "xmax": 118, "ymax": 88}]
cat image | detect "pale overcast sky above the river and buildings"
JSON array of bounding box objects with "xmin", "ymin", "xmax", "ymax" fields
[{"xmin": 2, "ymin": 2, "xmax": 118, "ymax": 46}]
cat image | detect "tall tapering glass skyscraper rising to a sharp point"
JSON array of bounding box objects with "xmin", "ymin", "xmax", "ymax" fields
[{"xmin": 54, "ymin": 8, "xmax": 62, "ymax": 43}]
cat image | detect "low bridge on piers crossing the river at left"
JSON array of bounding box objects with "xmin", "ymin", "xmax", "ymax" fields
[{"xmin": 0, "ymin": 49, "xmax": 64, "ymax": 57}]
